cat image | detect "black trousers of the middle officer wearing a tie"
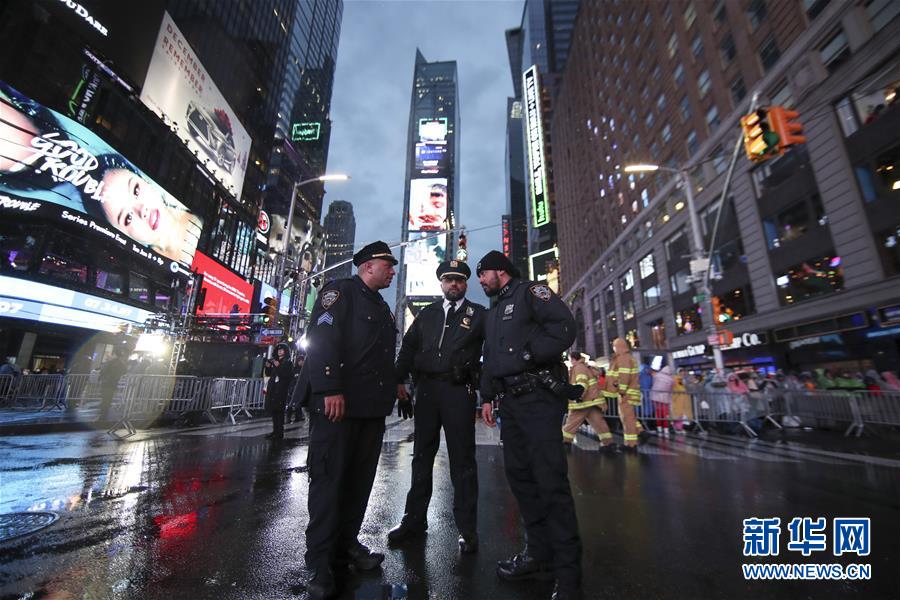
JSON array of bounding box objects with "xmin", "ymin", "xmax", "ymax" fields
[{"xmin": 404, "ymin": 377, "xmax": 478, "ymax": 534}]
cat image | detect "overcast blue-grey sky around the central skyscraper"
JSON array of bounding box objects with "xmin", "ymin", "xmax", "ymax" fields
[{"xmin": 322, "ymin": 0, "xmax": 523, "ymax": 306}]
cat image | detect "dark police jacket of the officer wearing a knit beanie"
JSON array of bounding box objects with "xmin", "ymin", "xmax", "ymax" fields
[{"xmin": 481, "ymin": 279, "xmax": 575, "ymax": 402}]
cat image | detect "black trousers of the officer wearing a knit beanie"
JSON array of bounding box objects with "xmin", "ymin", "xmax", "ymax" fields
[{"xmin": 500, "ymin": 389, "xmax": 581, "ymax": 586}]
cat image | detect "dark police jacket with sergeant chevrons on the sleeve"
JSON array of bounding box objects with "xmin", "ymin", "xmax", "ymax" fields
[{"xmin": 306, "ymin": 276, "xmax": 397, "ymax": 418}]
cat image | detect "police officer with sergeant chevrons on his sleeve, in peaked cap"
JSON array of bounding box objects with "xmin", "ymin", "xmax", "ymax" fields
[{"xmin": 306, "ymin": 241, "xmax": 397, "ymax": 598}]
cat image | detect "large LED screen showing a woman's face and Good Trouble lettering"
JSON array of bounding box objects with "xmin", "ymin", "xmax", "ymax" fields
[{"xmin": 0, "ymin": 81, "xmax": 203, "ymax": 266}]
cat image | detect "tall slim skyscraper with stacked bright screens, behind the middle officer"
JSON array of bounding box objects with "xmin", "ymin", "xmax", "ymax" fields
[{"xmin": 397, "ymin": 50, "xmax": 459, "ymax": 331}]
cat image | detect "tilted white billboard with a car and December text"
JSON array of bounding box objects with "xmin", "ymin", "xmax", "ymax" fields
[{"xmin": 141, "ymin": 13, "xmax": 251, "ymax": 198}]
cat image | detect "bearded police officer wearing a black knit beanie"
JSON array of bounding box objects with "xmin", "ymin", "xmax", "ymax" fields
[{"xmin": 476, "ymin": 250, "xmax": 581, "ymax": 600}]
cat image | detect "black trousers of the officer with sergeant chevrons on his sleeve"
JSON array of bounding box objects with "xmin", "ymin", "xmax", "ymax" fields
[{"xmin": 306, "ymin": 412, "xmax": 384, "ymax": 569}]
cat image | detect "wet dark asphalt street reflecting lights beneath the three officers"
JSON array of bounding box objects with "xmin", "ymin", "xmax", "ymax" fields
[{"xmin": 0, "ymin": 421, "xmax": 900, "ymax": 600}]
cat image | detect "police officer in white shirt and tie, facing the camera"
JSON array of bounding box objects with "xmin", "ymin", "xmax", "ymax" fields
[{"xmin": 388, "ymin": 260, "xmax": 486, "ymax": 553}]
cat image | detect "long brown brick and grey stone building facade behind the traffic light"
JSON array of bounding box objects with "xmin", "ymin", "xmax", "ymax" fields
[{"xmin": 552, "ymin": 0, "xmax": 900, "ymax": 371}]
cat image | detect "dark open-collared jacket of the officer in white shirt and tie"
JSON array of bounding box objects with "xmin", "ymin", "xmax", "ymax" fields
[{"xmin": 397, "ymin": 300, "xmax": 487, "ymax": 383}]
